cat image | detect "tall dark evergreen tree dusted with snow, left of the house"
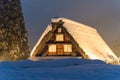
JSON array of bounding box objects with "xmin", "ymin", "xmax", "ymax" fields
[{"xmin": 0, "ymin": 0, "xmax": 29, "ymax": 61}]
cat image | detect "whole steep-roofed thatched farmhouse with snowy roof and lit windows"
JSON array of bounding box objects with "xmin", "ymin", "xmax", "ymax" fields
[{"xmin": 30, "ymin": 18, "xmax": 118, "ymax": 63}]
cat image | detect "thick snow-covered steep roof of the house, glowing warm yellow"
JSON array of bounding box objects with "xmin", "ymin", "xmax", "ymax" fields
[{"xmin": 31, "ymin": 18, "xmax": 118, "ymax": 62}]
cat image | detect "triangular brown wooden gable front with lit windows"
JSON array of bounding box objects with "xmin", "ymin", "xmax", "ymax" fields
[{"xmin": 35, "ymin": 21, "xmax": 83, "ymax": 57}]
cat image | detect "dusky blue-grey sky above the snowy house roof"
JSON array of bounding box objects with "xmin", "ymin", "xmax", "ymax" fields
[{"xmin": 21, "ymin": 0, "xmax": 120, "ymax": 49}]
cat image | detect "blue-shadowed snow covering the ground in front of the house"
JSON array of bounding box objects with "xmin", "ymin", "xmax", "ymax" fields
[{"xmin": 0, "ymin": 58, "xmax": 120, "ymax": 80}]
